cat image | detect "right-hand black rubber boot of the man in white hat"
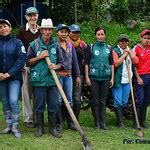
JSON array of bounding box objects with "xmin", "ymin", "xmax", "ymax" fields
[{"xmin": 48, "ymin": 112, "xmax": 61, "ymax": 138}]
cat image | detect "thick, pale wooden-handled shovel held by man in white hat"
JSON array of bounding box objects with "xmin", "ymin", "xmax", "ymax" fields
[{"xmin": 46, "ymin": 57, "xmax": 92, "ymax": 150}]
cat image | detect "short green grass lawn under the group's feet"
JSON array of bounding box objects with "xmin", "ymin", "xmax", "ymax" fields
[{"xmin": 0, "ymin": 103, "xmax": 150, "ymax": 150}]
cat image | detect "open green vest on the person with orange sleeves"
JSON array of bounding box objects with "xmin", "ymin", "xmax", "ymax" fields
[{"xmin": 113, "ymin": 46, "xmax": 123, "ymax": 87}]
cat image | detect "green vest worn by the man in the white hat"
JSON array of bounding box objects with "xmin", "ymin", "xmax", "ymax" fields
[{"xmin": 30, "ymin": 37, "xmax": 58, "ymax": 86}]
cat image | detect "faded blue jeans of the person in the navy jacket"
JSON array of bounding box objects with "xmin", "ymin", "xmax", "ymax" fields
[{"xmin": 0, "ymin": 80, "xmax": 21, "ymax": 114}]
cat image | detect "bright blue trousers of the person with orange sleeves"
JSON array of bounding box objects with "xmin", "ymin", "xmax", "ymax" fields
[{"xmin": 112, "ymin": 83, "xmax": 130, "ymax": 107}]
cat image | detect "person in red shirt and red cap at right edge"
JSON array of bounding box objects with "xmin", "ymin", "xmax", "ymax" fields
[{"xmin": 133, "ymin": 29, "xmax": 150, "ymax": 128}]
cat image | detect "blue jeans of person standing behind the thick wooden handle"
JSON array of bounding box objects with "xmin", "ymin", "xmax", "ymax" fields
[{"xmin": 59, "ymin": 76, "xmax": 73, "ymax": 106}]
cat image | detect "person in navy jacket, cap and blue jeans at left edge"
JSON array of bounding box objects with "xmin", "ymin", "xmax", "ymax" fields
[{"xmin": 0, "ymin": 19, "xmax": 26, "ymax": 138}]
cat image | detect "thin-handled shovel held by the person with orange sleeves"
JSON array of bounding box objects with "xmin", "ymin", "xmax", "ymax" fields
[{"xmin": 125, "ymin": 58, "xmax": 144, "ymax": 138}]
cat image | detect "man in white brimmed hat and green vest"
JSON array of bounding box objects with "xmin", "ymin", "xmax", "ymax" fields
[{"xmin": 27, "ymin": 18, "xmax": 63, "ymax": 138}]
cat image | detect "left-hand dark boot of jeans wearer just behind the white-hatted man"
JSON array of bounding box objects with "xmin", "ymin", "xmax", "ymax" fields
[{"xmin": 57, "ymin": 105, "xmax": 64, "ymax": 132}]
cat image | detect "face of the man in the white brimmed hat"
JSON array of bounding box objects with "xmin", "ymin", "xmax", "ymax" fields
[{"xmin": 41, "ymin": 28, "xmax": 53, "ymax": 40}]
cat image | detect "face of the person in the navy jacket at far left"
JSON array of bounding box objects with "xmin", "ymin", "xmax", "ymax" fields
[{"xmin": 0, "ymin": 23, "xmax": 12, "ymax": 36}]
